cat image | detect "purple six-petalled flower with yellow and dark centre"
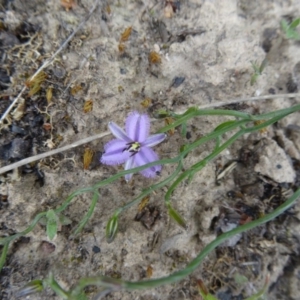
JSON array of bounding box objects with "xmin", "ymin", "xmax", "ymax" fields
[{"xmin": 101, "ymin": 111, "xmax": 166, "ymax": 181}]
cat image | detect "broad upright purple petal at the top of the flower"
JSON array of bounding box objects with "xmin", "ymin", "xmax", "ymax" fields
[{"xmin": 126, "ymin": 111, "xmax": 150, "ymax": 143}]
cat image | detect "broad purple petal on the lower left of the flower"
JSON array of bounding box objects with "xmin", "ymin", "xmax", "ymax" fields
[{"xmin": 101, "ymin": 139, "xmax": 131, "ymax": 166}]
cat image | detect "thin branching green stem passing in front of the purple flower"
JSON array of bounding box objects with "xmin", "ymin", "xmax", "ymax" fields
[{"xmin": 0, "ymin": 105, "xmax": 300, "ymax": 276}]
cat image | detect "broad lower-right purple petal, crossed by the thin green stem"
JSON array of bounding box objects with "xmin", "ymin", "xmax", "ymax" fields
[{"xmin": 134, "ymin": 147, "xmax": 161, "ymax": 178}]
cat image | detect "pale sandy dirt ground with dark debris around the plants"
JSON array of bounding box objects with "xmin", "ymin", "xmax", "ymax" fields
[{"xmin": 0, "ymin": 0, "xmax": 300, "ymax": 300}]
